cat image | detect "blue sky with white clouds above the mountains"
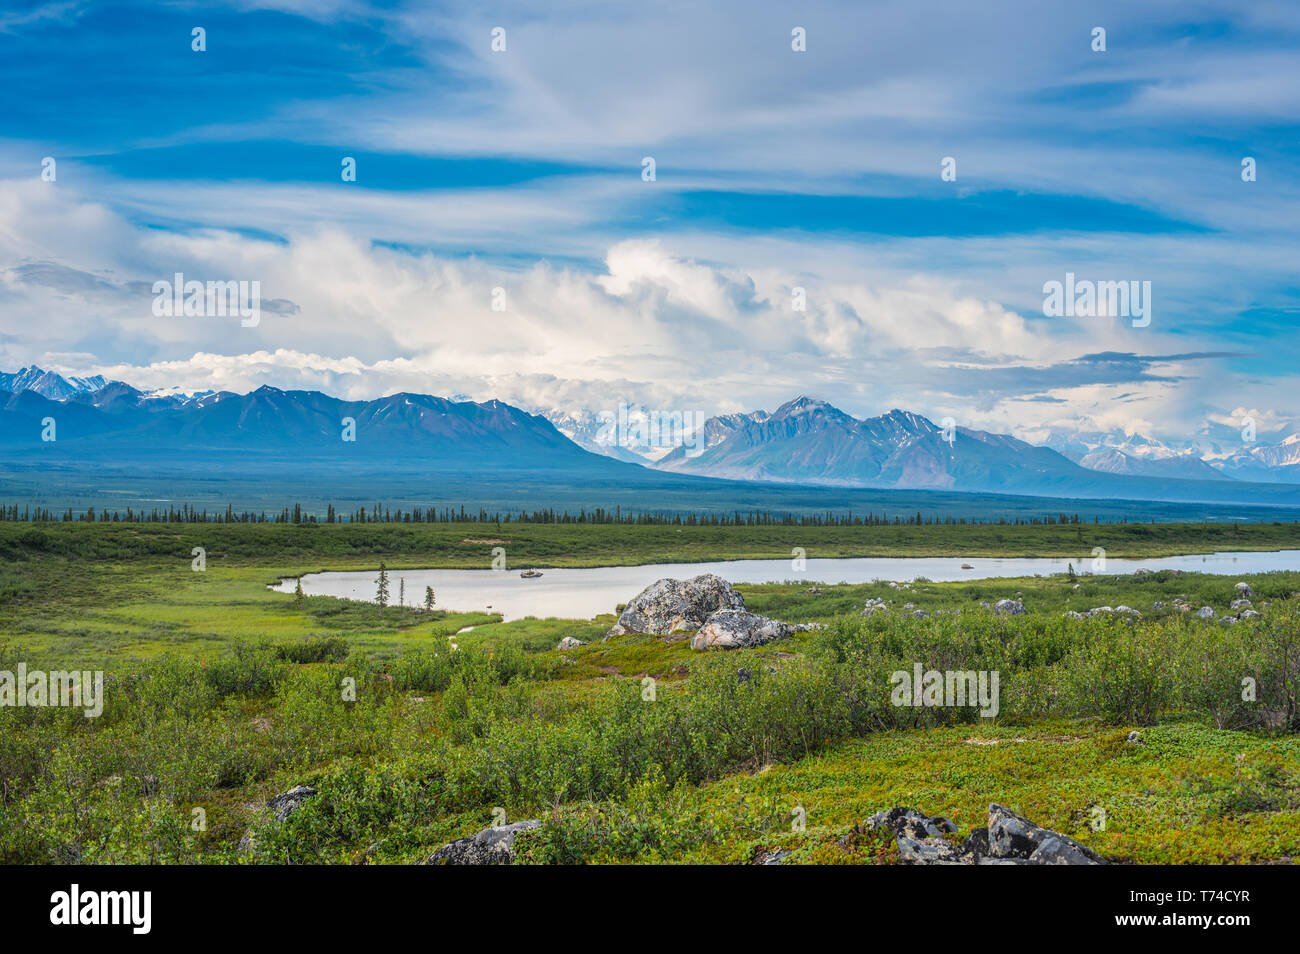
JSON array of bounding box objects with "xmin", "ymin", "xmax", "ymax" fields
[{"xmin": 0, "ymin": 0, "xmax": 1300, "ymax": 452}]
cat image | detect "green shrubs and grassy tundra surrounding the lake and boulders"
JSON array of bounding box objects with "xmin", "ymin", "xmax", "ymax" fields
[{"xmin": 0, "ymin": 524, "xmax": 1300, "ymax": 863}]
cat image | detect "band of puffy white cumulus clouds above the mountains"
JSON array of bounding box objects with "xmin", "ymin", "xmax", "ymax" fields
[{"xmin": 0, "ymin": 172, "xmax": 1258, "ymax": 444}]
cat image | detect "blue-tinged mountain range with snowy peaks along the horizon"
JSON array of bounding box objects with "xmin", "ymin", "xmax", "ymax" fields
[{"xmin": 0, "ymin": 368, "xmax": 1300, "ymax": 507}]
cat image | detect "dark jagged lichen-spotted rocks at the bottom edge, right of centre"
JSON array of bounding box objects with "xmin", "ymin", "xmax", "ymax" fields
[{"xmin": 867, "ymin": 803, "xmax": 1108, "ymax": 864}]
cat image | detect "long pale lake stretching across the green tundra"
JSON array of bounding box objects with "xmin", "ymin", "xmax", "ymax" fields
[{"xmin": 273, "ymin": 550, "xmax": 1300, "ymax": 620}]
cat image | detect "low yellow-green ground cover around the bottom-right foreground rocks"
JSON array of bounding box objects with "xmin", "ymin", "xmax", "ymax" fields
[{"xmin": 644, "ymin": 721, "xmax": 1300, "ymax": 864}]
